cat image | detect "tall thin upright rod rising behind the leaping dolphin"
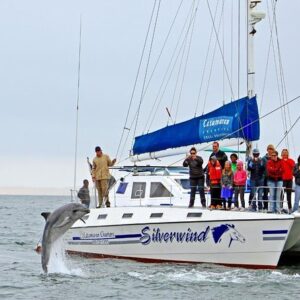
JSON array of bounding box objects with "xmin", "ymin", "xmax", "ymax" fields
[{"xmin": 71, "ymin": 15, "xmax": 82, "ymax": 201}]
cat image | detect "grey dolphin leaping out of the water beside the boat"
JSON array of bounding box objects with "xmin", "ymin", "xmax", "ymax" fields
[{"xmin": 41, "ymin": 203, "xmax": 90, "ymax": 273}]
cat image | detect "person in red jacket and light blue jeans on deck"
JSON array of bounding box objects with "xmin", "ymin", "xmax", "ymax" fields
[{"xmin": 266, "ymin": 151, "xmax": 283, "ymax": 213}]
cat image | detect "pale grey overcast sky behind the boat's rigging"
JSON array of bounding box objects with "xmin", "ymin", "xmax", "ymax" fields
[{"xmin": 0, "ymin": 0, "xmax": 300, "ymax": 188}]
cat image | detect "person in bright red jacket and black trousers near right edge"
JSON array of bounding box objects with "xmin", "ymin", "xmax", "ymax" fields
[{"xmin": 281, "ymin": 149, "xmax": 295, "ymax": 212}]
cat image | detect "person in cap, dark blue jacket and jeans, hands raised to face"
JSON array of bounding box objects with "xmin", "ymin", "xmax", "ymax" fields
[{"xmin": 247, "ymin": 149, "xmax": 266, "ymax": 211}]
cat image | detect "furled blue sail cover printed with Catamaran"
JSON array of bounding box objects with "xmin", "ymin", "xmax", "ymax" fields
[{"xmin": 133, "ymin": 97, "xmax": 260, "ymax": 155}]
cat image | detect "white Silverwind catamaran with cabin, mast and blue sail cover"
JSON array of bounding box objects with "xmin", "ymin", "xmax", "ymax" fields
[{"xmin": 64, "ymin": 0, "xmax": 300, "ymax": 269}]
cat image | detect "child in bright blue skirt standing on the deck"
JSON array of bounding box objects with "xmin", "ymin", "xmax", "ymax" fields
[{"xmin": 221, "ymin": 161, "xmax": 233, "ymax": 209}]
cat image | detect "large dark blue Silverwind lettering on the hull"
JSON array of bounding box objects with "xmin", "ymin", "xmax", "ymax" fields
[{"xmin": 140, "ymin": 226, "xmax": 210, "ymax": 245}]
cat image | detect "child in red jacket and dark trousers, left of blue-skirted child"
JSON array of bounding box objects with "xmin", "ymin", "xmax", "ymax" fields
[{"xmin": 207, "ymin": 156, "xmax": 222, "ymax": 209}]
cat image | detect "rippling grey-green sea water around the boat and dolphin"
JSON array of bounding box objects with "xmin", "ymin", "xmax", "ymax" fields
[{"xmin": 0, "ymin": 196, "xmax": 300, "ymax": 300}]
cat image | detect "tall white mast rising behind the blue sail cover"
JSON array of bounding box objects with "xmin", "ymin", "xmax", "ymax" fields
[{"xmin": 246, "ymin": 0, "xmax": 266, "ymax": 158}]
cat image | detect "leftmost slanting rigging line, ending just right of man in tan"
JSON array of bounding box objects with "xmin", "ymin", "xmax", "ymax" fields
[{"xmin": 115, "ymin": 0, "xmax": 156, "ymax": 162}]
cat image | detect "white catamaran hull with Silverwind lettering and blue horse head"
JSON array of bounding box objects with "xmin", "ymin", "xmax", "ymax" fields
[{"xmin": 65, "ymin": 207, "xmax": 294, "ymax": 268}]
